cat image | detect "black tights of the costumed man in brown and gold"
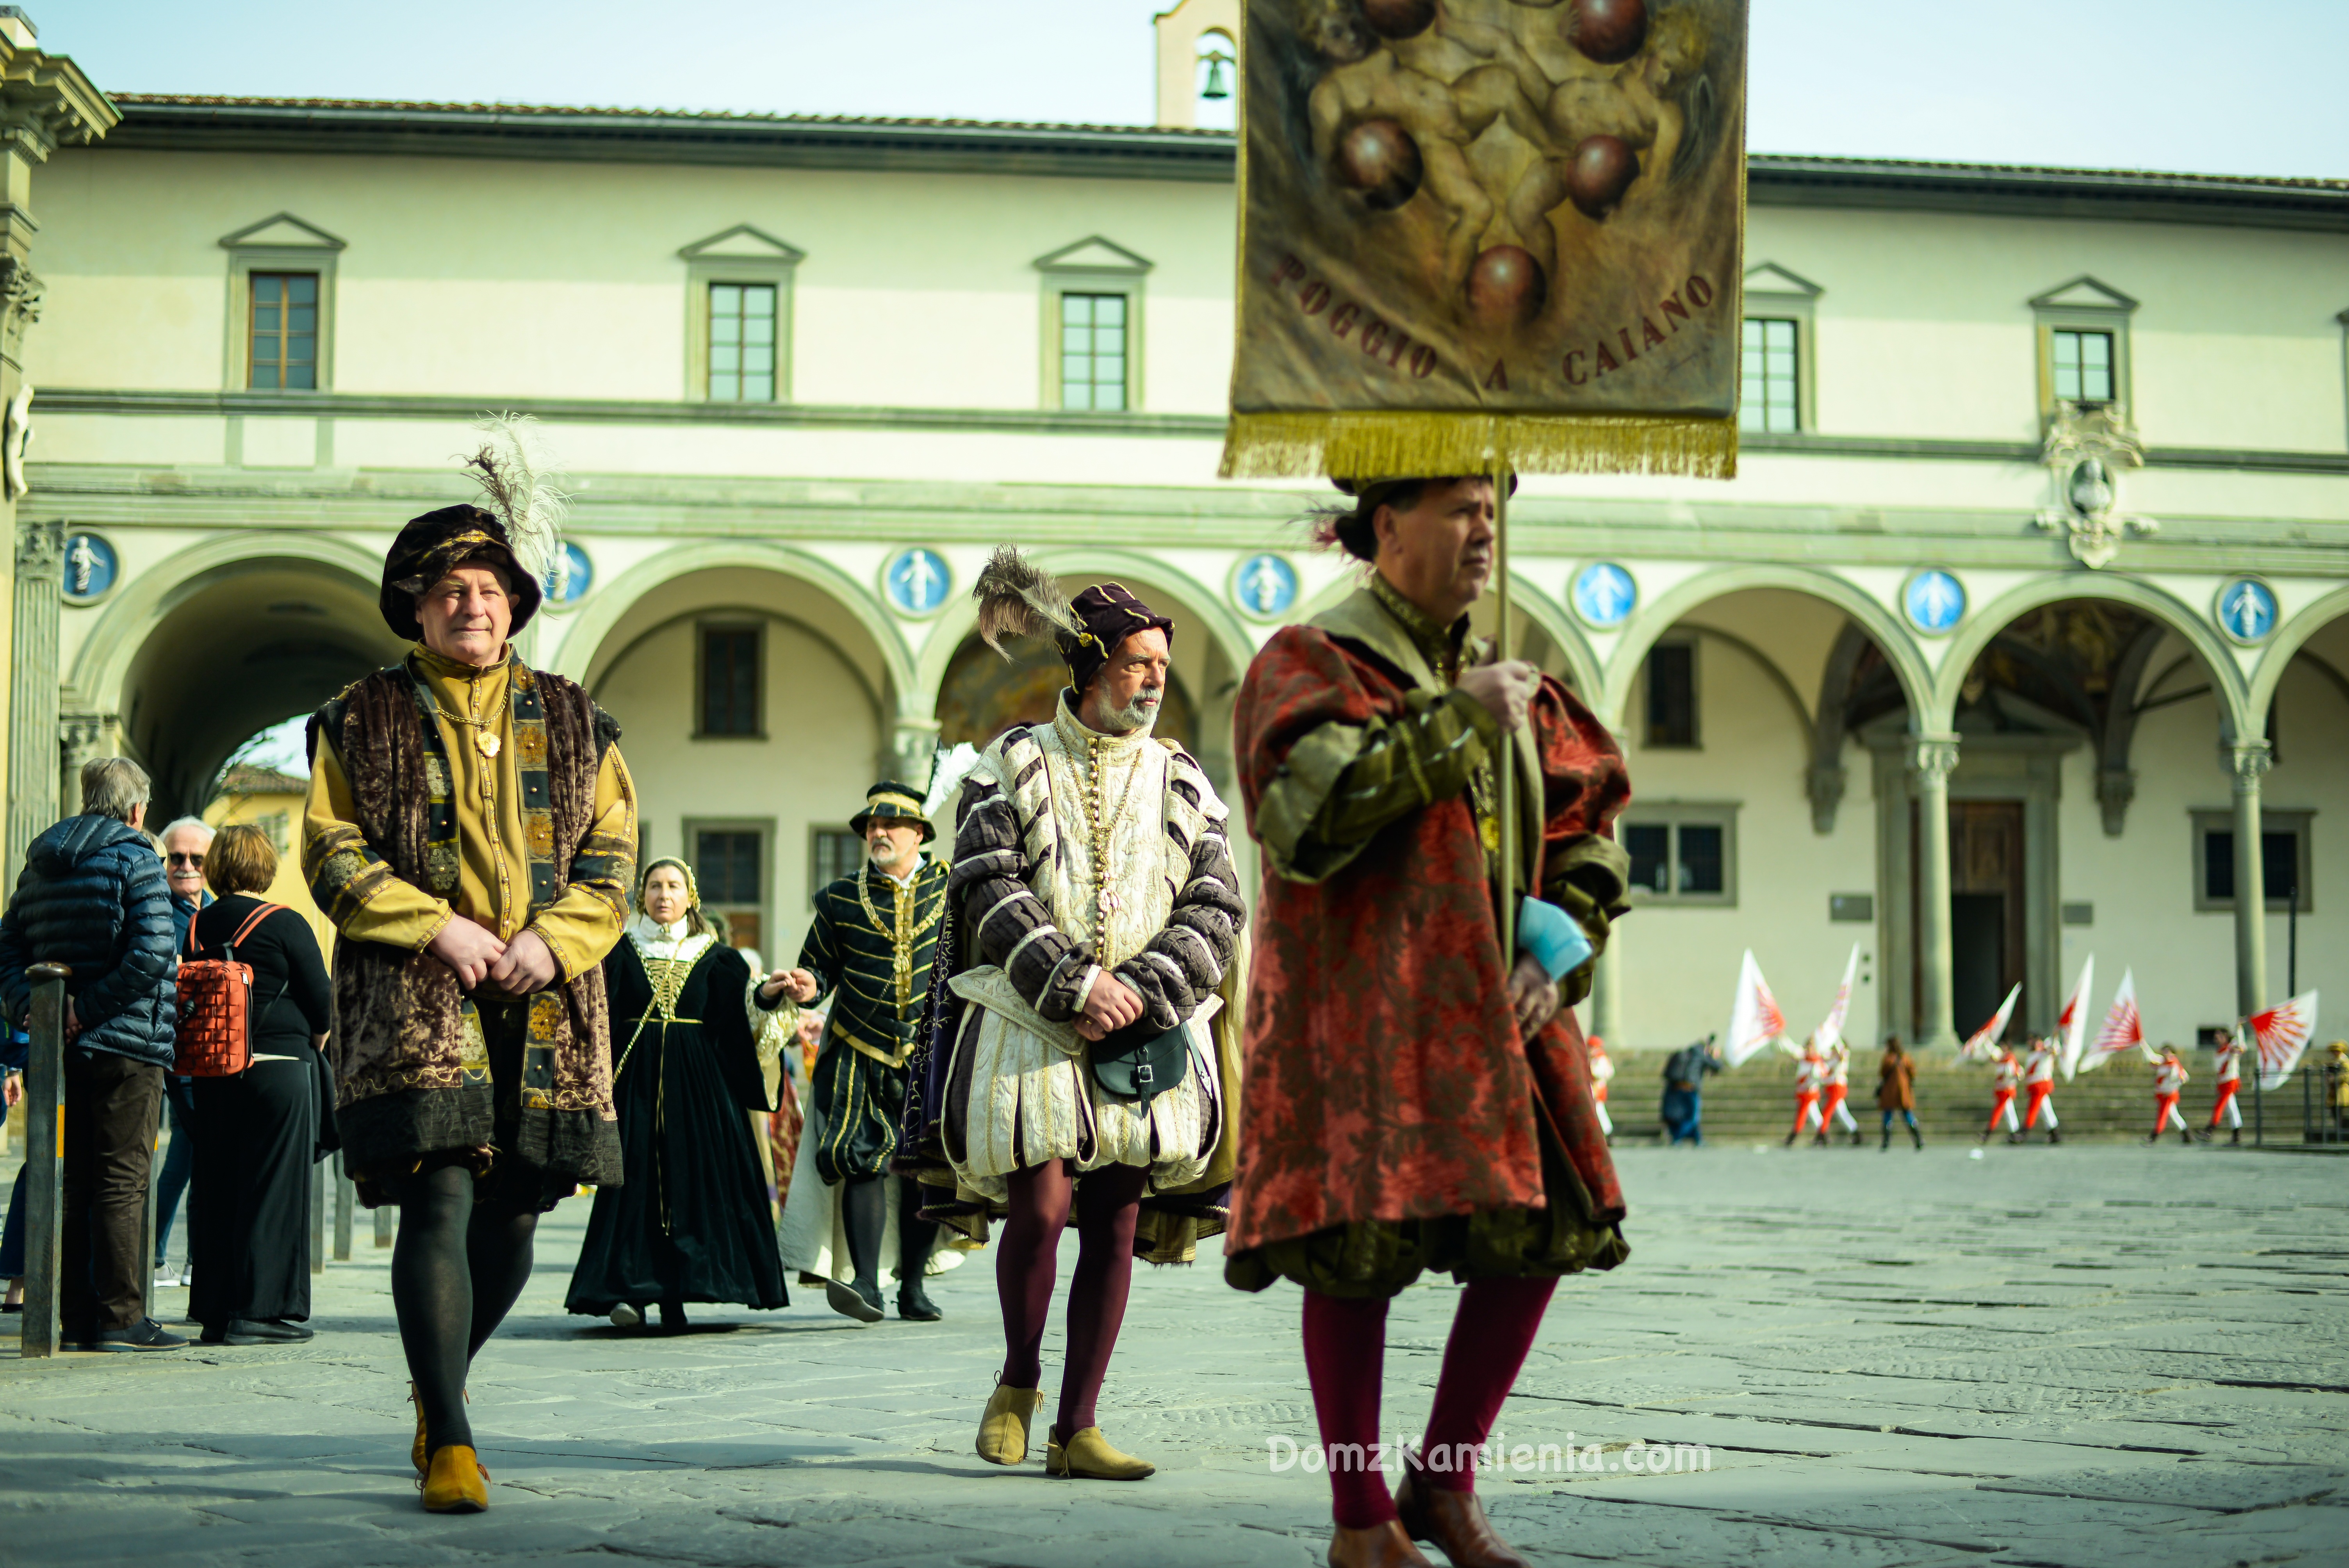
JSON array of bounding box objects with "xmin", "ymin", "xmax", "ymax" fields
[{"xmin": 392, "ymin": 1164, "xmax": 538, "ymax": 1453}]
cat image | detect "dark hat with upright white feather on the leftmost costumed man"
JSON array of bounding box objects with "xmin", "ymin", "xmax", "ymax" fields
[{"xmin": 376, "ymin": 413, "xmax": 571, "ymax": 641}]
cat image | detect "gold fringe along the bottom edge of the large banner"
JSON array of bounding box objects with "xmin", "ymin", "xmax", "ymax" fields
[{"xmin": 1219, "ymin": 408, "xmax": 1738, "ymax": 479}]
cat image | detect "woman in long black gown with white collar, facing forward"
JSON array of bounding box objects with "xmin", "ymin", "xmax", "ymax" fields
[{"xmin": 564, "ymin": 859, "xmax": 794, "ymax": 1333}]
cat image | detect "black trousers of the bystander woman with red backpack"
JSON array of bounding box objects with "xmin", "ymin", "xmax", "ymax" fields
[{"xmin": 188, "ymin": 1047, "xmax": 317, "ymax": 1329}]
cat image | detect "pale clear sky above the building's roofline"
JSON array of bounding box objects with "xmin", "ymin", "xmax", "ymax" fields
[{"xmin": 46, "ymin": 0, "xmax": 2349, "ymax": 178}]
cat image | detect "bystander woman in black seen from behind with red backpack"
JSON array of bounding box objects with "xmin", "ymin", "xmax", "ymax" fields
[{"xmin": 188, "ymin": 824, "xmax": 333, "ymax": 1345}]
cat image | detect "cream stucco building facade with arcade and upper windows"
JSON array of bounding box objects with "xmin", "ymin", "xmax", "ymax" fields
[{"xmin": 12, "ymin": 55, "xmax": 2349, "ymax": 1047}]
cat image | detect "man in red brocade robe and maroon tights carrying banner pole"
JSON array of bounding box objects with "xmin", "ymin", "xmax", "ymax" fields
[{"xmin": 1224, "ymin": 479, "xmax": 1630, "ymax": 1568}]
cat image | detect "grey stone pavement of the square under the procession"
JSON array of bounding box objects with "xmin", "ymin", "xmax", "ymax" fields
[{"xmin": 0, "ymin": 1146, "xmax": 2349, "ymax": 1568}]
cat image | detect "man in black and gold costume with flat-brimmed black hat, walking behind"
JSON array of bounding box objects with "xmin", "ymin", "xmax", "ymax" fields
[{"xmin": 782, "ymin": 779, "xmax": 946, "ymax": 1324}]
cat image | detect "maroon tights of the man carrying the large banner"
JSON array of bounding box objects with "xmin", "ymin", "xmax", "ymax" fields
[{"xmin": 1306, "ymin": 1279, "xmax": 1558, "ymax": 1531}]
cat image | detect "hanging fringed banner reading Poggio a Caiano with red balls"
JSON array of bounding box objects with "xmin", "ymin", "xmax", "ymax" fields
[{"xmin": 1224, "ymin": 0, "xmax": 1745, "ymax": 479}]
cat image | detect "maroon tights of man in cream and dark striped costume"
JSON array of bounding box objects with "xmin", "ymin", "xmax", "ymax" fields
[{"xmin": 996, "ymin": 1160, "xmax": 1149, "ymax": 1439}]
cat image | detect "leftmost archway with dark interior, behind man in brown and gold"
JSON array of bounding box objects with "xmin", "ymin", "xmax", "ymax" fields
[{"xmin": 63, "ymin": 531, "xmax": 406, "ymax": 819}]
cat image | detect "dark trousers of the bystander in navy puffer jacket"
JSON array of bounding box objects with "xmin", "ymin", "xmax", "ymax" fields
[{"xmin": 59, "ymin": 1044, "xmax": 162, "ymax": 1343}]
